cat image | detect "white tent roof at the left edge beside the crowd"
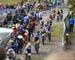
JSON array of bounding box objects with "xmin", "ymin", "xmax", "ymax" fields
[{"xmin": 0, "ymin": 28, "xmax": 13, "ymax": 43}]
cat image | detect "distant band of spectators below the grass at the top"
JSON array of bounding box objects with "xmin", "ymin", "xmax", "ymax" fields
[{"xmin": 0, "ymin": 0, "xmax": 62, "ymax": 14}]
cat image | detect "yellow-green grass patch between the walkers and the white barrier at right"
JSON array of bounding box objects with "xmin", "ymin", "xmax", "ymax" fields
[{"xmin": 52, "ymin": 25, "xmax": 63, "ymax": 40}]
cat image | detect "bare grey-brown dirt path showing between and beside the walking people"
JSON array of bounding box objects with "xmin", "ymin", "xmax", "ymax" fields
[{"xmin": 32, "ymin": 9, "xmax": 67, "ymax": 56}]
